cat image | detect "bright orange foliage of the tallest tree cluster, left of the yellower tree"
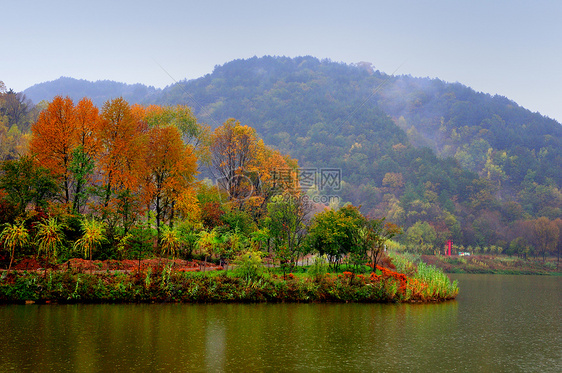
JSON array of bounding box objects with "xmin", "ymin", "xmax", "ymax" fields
[{"xmin": 30, "ymin": 97, "xmax": 199, "ymax": 230}]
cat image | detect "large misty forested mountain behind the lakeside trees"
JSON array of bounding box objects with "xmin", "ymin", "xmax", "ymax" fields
[{"xmin": 6, "ymin": 57, "xmax": 562, "ymax": 264}]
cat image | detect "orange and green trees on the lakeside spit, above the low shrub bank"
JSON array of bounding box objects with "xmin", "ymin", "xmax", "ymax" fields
[{"xmin": 0, "ymin": 89, "xmax": 400, "ymax": 276}]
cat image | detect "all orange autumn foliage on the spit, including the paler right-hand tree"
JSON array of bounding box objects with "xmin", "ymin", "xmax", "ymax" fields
[{"xmin": 25, "ymin": 96, "xmax": 297, "ymax": 232}]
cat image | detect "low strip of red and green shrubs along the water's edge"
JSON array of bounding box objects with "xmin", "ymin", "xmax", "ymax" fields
[{"xmin": 0, "ymin": 258, "xmax": 458, "ymax": 303}]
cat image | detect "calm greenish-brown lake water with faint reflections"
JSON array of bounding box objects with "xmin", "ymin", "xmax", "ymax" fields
[{"xmin": 0, "ymin": 275, "xmax": 562, "ymax": 372}]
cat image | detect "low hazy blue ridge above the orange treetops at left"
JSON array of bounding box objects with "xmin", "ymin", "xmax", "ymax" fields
[{"xmin": 23, "ymin": 77, "xmax": 161, "ymax": 107}]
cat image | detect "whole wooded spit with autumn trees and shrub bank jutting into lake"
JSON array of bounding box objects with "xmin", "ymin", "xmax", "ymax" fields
[{"xmin": 0, "ymin": 96, "xmax": 458, "ymax": 303}]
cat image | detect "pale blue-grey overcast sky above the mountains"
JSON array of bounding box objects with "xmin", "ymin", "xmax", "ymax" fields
[{"xmin": 0, "ymin": 0, "xmax": 562, "ymax": 122}]
